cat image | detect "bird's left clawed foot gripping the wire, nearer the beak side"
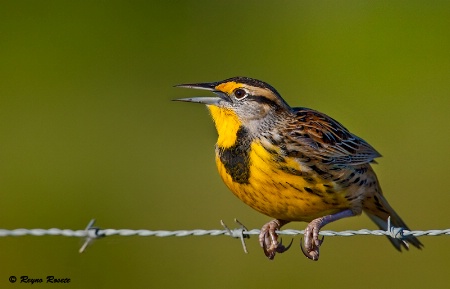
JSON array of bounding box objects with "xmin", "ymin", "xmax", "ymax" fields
[{"xmin": 259, "ymin": 219, "xmax": 292, "ymax": 260}]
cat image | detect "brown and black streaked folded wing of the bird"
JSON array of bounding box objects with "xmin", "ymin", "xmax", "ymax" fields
[{"xmin": 286, "ymin": 108, "xmax": 381, "ymax": 165}]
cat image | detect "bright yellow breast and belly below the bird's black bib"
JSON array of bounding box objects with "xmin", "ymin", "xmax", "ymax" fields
[{"xmin": 216, "ymin": 141, "xmax": 350, "ymax": 221}]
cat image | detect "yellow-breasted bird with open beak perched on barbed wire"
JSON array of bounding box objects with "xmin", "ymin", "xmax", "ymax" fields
[{"xmin": 175, "ymin": 76, "xmax": 423, "ymax": 261}]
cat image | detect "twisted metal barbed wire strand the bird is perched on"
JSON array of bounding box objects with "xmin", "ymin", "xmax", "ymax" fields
[{"xmin": 0, "ymin": 219, "xmax": 450, "ymax": 253}]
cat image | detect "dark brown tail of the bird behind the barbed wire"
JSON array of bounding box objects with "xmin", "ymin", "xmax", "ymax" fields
[{"xmin": 364, "ymin": 193, "xmax": 423, "ymax": 251}]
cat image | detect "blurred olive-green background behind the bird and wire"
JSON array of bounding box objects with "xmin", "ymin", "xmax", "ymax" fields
[{"xmin": 0, "ymin": 1, "xmax": 450, "ymax": 288}]
